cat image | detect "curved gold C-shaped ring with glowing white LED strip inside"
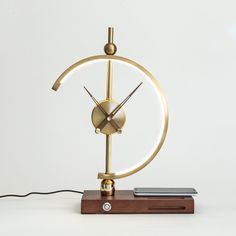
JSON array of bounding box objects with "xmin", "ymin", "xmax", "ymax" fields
[{"xmin": 52, "ymin": 55, "xmax": 168, "ymax": 179}]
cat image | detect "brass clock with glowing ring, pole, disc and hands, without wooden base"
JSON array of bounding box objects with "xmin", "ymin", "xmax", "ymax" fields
[{"xmin": 52, "ymin": 27, "xmax": 168, "ymax": 196}]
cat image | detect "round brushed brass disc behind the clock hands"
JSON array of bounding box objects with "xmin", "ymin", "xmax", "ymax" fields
[{"xmin": 91, "ymin": 100, "xmax": 126, "ymax": 134}]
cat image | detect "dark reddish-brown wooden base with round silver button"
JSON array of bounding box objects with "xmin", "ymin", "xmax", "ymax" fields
[{"xmin": 81, "ymin": 190, "xmax": 194, "ymax": 214}]
